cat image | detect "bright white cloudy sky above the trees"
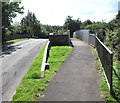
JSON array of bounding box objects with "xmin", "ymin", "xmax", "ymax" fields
[{"xmin": 14, "ymin": 0, "xmax": 120, "ymax": 25}]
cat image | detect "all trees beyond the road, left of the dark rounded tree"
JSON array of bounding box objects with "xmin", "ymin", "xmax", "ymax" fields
[{"xmin": 2, "ymin": 2, "xmax": 62, "ymax": 43}]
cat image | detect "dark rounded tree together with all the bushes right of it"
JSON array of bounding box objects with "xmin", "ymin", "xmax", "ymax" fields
[{"xmin": 63, "ymin": 11, "xmax": 120, "ymax": 61}]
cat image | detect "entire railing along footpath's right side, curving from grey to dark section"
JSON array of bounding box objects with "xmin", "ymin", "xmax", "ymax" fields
[{"xmin": 73, "ymin": 30, "xmax": 113, "ymax": 93}]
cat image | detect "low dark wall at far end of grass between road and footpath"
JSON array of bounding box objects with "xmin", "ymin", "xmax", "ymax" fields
[{"xmin": 49, "ymin": 34, "xmax": 70, "ymax": 46}]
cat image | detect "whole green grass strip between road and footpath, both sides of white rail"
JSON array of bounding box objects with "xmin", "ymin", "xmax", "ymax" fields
[{"xmin": 13, "ymin": 46, "xmax": 71, "ymax": 101}]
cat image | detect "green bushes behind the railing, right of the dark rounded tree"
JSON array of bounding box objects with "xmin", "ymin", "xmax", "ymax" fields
[{"xmin": 82, "ymin": 11, "xmax": 120, "ymax": 61}]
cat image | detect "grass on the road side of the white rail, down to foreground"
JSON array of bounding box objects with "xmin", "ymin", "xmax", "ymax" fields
[{"xmin": 13, "ymin": 46, "xmax": 46, "ymax": 101}]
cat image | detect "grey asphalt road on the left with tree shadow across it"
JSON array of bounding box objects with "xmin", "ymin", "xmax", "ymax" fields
[{"xmin": 0, "ymin": 39, "xmax": 47, "ymax": 101}]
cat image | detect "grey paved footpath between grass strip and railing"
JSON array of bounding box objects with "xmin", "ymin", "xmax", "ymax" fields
[{"xmin": 39, "ymin": 39, "xmax": 102, "ymax": 101}]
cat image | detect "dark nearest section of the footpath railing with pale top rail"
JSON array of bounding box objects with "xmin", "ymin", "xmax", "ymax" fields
[{"xmin": 95, "ymin": 37, "xmax": 113, "ymax": 93}]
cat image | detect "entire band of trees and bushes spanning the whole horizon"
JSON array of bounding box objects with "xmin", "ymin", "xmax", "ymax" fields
[{"xmin": 2, "ymin": 2, "xmax": 120, "ymax": 60}]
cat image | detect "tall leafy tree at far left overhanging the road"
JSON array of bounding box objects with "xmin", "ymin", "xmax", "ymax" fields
[{"xmin": 2, "ymin": 2, "xmax": 24, "ymax": 42}]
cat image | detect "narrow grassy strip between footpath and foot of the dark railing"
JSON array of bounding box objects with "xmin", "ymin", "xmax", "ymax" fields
[{"xmin": 92, "ymin": 48, "xmax": 118, "ymax": 103}]
